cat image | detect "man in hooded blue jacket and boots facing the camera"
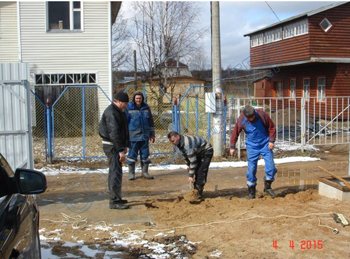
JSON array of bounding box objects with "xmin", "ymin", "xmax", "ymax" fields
[{"xmin": 126, "ymin": 92, "xmax": 155, "ymax": 180}]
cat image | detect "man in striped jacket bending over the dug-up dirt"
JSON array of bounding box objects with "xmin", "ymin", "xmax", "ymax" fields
[{"xmin": 168, "ymin": 131, "xmax": 213, "ymax": 203}]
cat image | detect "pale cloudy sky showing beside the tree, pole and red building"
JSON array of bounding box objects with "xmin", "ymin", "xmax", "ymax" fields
[{"xmin": 121, "ymin": 1, "xmax": 336, "ymax": 68}]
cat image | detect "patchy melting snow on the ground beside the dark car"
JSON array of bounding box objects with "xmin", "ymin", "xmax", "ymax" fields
[{"xmin": 39, "ymin": 225, "xmax": 198, "ymax": 259}]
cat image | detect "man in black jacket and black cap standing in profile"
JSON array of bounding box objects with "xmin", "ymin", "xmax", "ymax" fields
[{"xmin": 99, "ymin": 91, "xmax": 129, "ymax": 209}]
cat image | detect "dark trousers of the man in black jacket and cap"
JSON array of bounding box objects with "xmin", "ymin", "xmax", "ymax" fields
[{"xmin": 103, "ymin": 145, "xmax": 123, "ymax": 202}]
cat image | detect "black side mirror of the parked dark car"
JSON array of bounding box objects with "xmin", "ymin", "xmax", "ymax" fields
[{"xmin": 15, "ymin": 168, "xmax": 47, "ymax": 194}]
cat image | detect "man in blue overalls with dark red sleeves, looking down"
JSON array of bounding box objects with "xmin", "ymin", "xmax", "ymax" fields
[{"xmin": 230, "ymin": 105, "xmax": 277, "ymax": 199}]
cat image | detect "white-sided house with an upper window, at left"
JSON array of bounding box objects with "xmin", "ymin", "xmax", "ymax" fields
[{"xmin": 0, "ymin": 1, "xmax": 120, "ymax": 113}]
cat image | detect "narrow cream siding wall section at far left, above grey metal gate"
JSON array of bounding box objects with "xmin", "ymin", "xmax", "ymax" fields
[{"xmin": 0, "ymin": 2, "xmax": 19, "ymax": 63}]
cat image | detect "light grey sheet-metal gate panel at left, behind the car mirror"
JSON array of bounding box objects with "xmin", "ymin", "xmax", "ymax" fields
[{"xmin": 0, "ymin": 63, "xmax": 33, "ymax": 169}]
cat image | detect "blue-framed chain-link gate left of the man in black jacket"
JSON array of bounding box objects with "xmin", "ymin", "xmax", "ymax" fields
[{"xmin": 33, "ymin": 85, "xmax": 110, "ymax": 163}]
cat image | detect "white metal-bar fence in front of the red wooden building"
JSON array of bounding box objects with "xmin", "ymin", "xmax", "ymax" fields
[{"xmin": 226, "ymin": 96, "xmax": 350, "ymax": 156}]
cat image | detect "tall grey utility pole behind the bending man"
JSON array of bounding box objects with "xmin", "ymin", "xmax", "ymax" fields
[{"xmin": 210, "ymin": 1, "xmax": 226, "ymax": 157}]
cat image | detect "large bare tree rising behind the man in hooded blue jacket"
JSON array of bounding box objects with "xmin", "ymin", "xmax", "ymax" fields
[{"xmin": 133, "ymin": 1, "xmax": 206, "ymax": 112}]
